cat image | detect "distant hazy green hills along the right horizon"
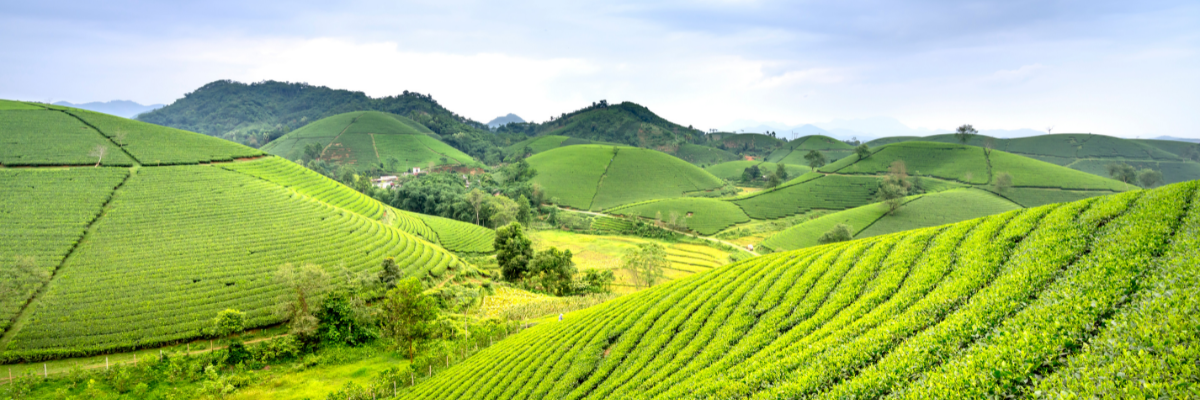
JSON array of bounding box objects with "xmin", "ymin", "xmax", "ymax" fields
[{"xmin": 868, "ymin": 133, "xmax": 1200, "ymax": 184}]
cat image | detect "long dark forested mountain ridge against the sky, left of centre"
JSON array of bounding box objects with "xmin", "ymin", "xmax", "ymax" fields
[{"xmin": 138, "ymin": 79, "xmax": 487, "ymax": 147}]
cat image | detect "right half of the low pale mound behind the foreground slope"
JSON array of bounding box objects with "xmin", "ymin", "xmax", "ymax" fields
[{"xmin": 854, "ymin": 189, "xmax": 1022, "ymax": 238}]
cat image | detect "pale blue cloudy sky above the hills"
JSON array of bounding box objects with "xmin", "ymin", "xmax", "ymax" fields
[{"xmin": 0, "ymin": 0, "xmax": 1200, "ymax": 138}]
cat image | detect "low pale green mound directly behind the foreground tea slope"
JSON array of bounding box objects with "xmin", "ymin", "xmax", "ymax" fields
[{"xmin": 762, "ymin": 189, "xmax": 1022, "ymax": 250}]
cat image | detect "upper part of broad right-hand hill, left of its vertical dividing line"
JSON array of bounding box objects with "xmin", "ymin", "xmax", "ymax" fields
[{"xmin": 820, "ymin": 142, "xmax": 988, "ymax": 185}]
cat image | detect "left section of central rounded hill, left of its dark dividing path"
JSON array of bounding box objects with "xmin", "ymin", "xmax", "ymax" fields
[{"xmin": 526, "ymin": 144, "xmax": 616, "ymax": 209}]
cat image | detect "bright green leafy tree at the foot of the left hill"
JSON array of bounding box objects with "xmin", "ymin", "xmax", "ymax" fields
[{"xmin": 380, "ymin": 277, "xmax": 438, "ymax": 363}]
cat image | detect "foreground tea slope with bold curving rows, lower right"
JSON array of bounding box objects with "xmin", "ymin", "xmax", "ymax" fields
[{"xmin": 401, "ymin": 183, "xmax": 1200, "ymax": 399}]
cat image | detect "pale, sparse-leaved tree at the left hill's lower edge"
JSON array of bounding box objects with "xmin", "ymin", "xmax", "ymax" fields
[{"xmin": 275, "ymin": 263, "xmax": 329, "ymax": 339}]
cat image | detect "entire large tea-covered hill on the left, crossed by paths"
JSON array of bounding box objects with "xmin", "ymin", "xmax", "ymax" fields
[{"xmin": 0, "ymin": 102, "xmax": 494, "ymax": 362}]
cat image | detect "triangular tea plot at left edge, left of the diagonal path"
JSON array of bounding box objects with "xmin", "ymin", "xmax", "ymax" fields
[{"xmin": 0, "ymin": 167, "xmax": 128, "ymax": 333}]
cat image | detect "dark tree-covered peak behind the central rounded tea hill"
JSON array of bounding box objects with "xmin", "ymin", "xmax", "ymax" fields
[{"xmin": 497, "ymin": 101, "xmax": 702, "ymax": 154}]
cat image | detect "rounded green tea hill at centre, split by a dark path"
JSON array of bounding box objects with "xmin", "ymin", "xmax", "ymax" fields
[{"xmin": 527, "ymin": 144, "xmax": 722, "ymax": 210}]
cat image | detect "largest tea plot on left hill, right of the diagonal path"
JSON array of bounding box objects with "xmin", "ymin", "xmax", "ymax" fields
[{"xmin": 4, "ymin": 166, "xmax": 462, "ymax": 359}]
